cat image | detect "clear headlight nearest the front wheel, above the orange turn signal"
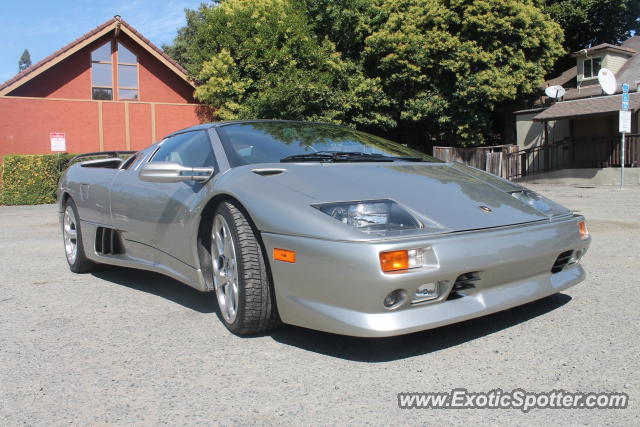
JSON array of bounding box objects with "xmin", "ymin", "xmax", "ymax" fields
[{"xmin": 312, "ymin": 200, "xmax": 422, "ymax": 232}]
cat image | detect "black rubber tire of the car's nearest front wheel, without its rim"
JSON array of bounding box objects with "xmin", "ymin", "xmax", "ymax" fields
[{"xmin": 212, "ymin": 202, "xmax": 280, "ymax": 335}]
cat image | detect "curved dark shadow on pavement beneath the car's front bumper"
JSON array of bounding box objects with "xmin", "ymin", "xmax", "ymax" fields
[{"xmin": 270, "ymin": 294, "xmax": 571, "ymax": 363}]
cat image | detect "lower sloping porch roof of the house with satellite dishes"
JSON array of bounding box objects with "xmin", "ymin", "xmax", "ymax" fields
[{"xmin": 533, "ymin": 92, "xmax": 640, "ymax": 121}]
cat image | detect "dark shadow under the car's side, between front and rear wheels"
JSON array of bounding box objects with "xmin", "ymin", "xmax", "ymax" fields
[{"xmin": 92, "ymin": 267, "xmax": 218, "ymax": 313}]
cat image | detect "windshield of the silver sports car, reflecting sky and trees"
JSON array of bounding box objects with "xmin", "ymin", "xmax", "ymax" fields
[{"xmin": 218, "ymin": 121, "xmax": 440, "ymax": 167}]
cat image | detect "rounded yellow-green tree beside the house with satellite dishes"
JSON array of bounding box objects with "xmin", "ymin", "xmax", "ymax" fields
[{"xmin": 364, "ymin": 0, "xmax": 562, "ymax": 145}]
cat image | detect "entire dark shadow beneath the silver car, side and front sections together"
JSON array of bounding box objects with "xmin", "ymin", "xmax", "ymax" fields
[{"xmin": 92, "ymin": 267, "xmax": 571, "ymax": 363}]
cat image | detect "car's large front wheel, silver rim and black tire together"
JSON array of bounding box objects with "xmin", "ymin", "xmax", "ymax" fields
[{"xmin": 211, "ymin": 202, "xmax": 279, "ymax": 335}]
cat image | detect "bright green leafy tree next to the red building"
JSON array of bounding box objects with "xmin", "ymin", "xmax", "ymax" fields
[{"xmin": 172, "ymin": 0, "xmax": 392, "ymax": 126}]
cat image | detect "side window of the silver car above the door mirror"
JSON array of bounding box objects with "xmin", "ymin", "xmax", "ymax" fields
[{"xmin": 151, "ymin": 131, "xmax": 215, "ymax": 168}]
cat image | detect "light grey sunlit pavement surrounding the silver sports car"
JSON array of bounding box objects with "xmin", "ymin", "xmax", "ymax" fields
[{"xmin": 0, "ymin": 185, "xmax": 640, "ymax": 426}]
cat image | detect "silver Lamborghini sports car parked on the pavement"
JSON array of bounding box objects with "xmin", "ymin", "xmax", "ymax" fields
[{"xmin": 58, "ymin": 121, "xmax": 590, "ymax": 337}]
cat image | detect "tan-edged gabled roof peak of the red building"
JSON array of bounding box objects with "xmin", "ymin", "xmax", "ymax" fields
[{"xmin": 0, "ymin": 15, "xmax": 193, "ymax": 96}]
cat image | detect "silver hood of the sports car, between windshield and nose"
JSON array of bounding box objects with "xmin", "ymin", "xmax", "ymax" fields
[{"xmin": 221, "ymin": 162, "xmax": 560, "ymax": 238}]
